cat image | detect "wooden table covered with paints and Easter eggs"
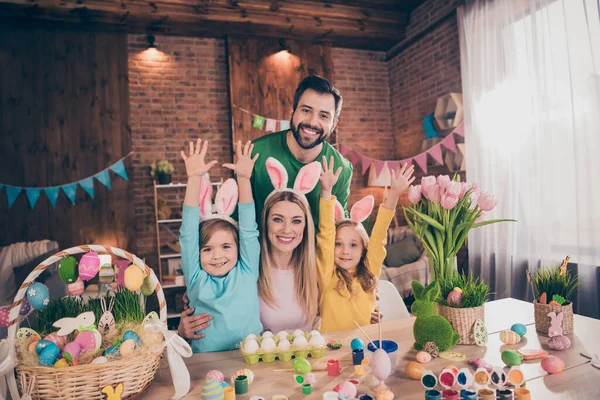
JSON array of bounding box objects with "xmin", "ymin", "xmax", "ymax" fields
[{"xmin": 143, "ymin": 299, "xmax": 600, "ymax": 400}]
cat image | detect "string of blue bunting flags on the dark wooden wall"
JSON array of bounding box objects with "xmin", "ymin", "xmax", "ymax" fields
[{"xmin": 0, "ymin": 152, "xmax": 133, "ymax": 210}]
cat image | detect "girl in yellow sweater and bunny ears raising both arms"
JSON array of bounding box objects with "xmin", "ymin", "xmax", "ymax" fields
[{"xmin": 317, "ymin": 157, "xmax": 415, "ymax": 333}]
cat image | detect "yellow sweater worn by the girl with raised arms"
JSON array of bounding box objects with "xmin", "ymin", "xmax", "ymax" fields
[{"xmin": 317, "ymin": 196, "xmax": 394, "ymax": 333}]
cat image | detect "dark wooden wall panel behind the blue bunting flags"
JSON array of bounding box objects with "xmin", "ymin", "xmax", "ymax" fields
[{"xmin": 0, "ymin": 26, "xmax": 135, "ymax": 251}]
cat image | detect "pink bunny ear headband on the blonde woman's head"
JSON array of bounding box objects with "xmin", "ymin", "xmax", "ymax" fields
[{"xmin": 265, "ymin": 157, "xmax": 321, "ymax": 204}]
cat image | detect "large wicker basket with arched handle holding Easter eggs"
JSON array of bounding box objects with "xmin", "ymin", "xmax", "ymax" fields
[{"xmin": 8, "ymin": 245, "xmax": 167, "ymax": 400}]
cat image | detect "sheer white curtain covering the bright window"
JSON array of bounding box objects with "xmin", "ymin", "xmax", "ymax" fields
[{"xmin": 458, "ymin": 0, "xmax": 600, "ymax": 317}]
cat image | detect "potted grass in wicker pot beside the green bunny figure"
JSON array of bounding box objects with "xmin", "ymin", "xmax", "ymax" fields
[{"xmin": 436, "ymin": 273, "xmax": 490, "ymax": 344}]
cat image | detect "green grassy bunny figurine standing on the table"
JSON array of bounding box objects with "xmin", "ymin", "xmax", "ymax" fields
[{"xmin": 412, "ymin": 281, "xmax": 460, "ymax": 351}]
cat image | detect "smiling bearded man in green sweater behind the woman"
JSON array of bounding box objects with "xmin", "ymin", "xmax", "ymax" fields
[{"xmin": 251, "ymin": 75, "xmax": 352, "ymax": 226}]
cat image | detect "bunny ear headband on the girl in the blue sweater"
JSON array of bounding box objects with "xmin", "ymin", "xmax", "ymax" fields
[{"xmin": 199, "ymin": 176, "xmax": 238, "ymax": 228}]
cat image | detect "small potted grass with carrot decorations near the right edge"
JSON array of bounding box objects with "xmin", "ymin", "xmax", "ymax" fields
[{"xmin": 527, "ymin": 257, "xmax": 579, "ymax": 335}]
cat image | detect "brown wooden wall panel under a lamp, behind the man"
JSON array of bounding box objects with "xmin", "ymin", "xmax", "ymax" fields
[{"xmin": 227, "ymin": 37, "xmax": 335, "ymax": 147}]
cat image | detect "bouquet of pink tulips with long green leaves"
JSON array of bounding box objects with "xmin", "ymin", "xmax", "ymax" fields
[{"xmin": 403, "ymin": 175, "xmax": 515, "ymax": 280}]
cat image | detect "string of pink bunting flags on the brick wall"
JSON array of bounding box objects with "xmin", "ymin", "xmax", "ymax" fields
[{"xmin": 339, "ymin": 123, "xmax": 465, "ymax": 177}]
